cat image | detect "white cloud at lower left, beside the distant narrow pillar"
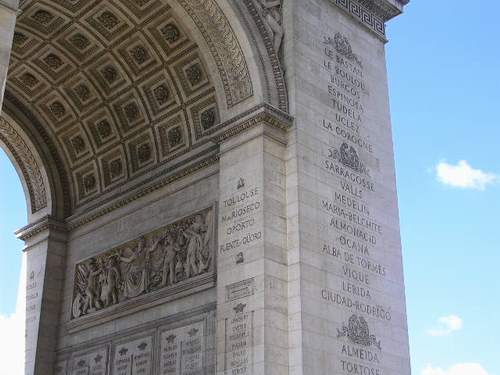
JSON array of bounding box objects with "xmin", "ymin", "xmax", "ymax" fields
[{"xmin": 0, "ymin": 255, "xmax": 26, "ymax": 375}]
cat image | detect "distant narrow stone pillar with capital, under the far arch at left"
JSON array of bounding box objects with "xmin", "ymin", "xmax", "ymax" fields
[{"xmin": 17, "ymin": 218, "xmax": 66, "ymax": 375}]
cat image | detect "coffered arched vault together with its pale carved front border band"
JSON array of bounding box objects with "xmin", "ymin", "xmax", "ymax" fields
[{"xmin": 4, "ymin": 0, "xmax": 287, "ymax": 220}]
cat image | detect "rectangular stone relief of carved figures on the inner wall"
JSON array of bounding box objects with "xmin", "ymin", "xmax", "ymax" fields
[{"xmin": 72, "ymin": 209, "xmax": 214, "ymax": 319}]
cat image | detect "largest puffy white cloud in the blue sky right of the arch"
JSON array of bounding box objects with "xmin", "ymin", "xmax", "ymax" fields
[{"xmin": 436, "ymin": 160, "xmax": 500, "ymax": 190}]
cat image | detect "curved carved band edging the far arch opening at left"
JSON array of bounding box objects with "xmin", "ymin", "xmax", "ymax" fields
[{"xmin": 0, "ymin": 117, "xmax": 47, "ymax": 213}]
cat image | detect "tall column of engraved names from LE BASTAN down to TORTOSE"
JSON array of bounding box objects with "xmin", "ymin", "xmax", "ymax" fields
[{"xmin": 318, "ymin": 32, "xmax": 393, "ymax": 374}]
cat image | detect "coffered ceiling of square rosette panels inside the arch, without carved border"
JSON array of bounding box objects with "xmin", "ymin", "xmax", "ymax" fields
[{"xmin": 7, "ymin": 0, "xmax": 220, "ymax": 207}]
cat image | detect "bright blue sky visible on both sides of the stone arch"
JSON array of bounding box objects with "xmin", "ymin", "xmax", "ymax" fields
[{"xmin": 0, "ymin": 0, "xmax": 500, "ymax": 375}]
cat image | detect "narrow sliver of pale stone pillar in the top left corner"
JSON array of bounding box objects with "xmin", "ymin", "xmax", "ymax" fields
[{"xmin": 0, "ymin": 0, "xmax": 18, "ymax": 110}]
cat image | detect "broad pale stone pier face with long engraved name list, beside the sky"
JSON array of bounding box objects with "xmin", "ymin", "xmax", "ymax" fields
[{"xmin": 284, "ymin": 0, "xmax": 410, "ymax": 375}]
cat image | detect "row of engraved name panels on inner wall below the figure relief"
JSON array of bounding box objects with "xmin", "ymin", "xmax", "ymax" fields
[{"xmin": 55, "ymin": 312, "xmax": 216, "ymax": 375}]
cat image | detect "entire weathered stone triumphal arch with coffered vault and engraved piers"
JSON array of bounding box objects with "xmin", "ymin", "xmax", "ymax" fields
[{"xmin": 0, "ymin": 0, "xmax": 410, "ymax": 375}]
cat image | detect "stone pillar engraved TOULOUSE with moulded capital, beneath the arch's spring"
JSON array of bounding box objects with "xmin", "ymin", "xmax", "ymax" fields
[{"xmin": 217, "ymin": 106, "xmax": 288, "ymax": 375}]
